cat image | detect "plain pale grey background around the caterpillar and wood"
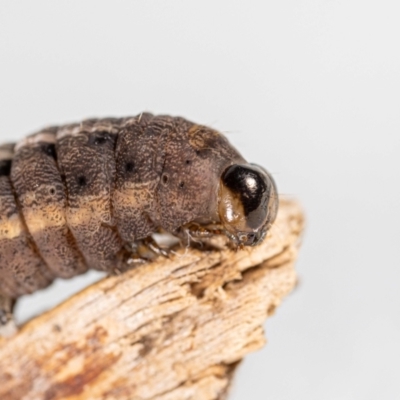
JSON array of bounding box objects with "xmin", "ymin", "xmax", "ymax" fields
[{"xmin": 0, "ymin": 0, "xmax": 400, "ymax": 400}]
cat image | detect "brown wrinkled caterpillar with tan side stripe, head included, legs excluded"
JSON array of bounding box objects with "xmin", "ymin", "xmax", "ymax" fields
[{"xmin": 0, "ymin": 113, "xmax": 278, "ymax": 332}]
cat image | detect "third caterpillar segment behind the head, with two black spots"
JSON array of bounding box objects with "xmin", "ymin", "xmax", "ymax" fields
[{"xmin": 56, "ymin": 120, "xmax": 122, "ymax": 271}]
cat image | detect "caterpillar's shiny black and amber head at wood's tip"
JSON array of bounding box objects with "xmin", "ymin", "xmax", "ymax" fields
[{"xmin": 218, "ymin": 164, "xmax": 278, "ymax": 246}]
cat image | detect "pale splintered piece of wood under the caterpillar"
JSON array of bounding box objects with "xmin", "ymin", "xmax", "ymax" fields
[{"xmin": 0, "ymin": 200, "xmax": 303, "ymax": 400}]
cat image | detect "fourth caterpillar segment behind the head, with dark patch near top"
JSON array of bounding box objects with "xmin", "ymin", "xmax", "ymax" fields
[{"xmin": 10, "ymin": 128, "xmax": 87, "ymax": 278}]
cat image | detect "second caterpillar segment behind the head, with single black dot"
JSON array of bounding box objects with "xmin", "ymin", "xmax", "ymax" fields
[{"xmin": 112, "ymin": 113, "xmax": 166, "ymax": 242}]
